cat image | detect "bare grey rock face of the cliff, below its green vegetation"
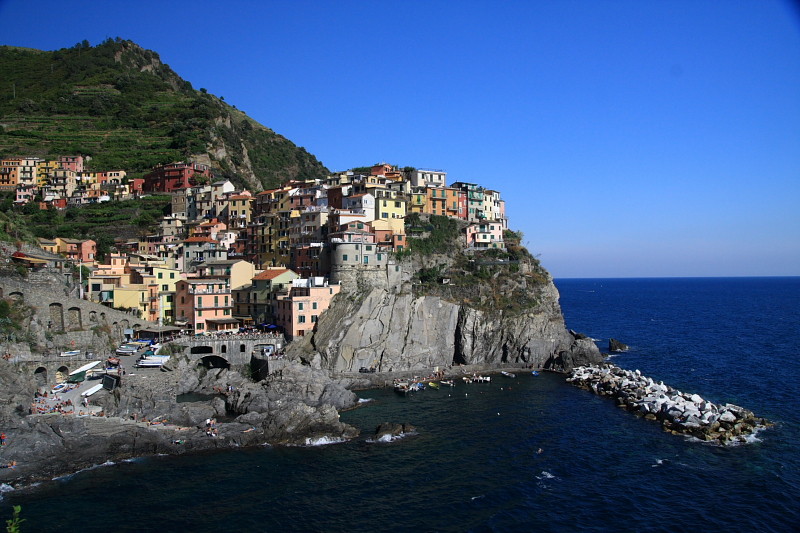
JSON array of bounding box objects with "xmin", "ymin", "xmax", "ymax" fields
[{"xmin": 289, "ymin": 268, "xmax": 602, "ymax": 372}]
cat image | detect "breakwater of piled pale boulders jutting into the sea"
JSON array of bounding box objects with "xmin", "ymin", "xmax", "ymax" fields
[{"xmin": 567, "ymin": 364, "xmax": 772, "ymax": 445}]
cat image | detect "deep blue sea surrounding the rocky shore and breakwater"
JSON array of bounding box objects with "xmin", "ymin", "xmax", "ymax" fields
[{"xmin": 0, "ymin": 277, "xmax": 800, "ymax": 532}]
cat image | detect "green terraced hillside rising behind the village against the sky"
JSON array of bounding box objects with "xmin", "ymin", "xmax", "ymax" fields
[{"xmin": 0, "ymin": 38, "xmax": 328, "ymax": 189}]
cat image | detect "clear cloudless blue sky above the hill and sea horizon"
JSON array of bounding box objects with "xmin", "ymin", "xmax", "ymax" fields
[{"xmin": 0, "ymin": 0, "xmax": 800, "ymax": 277}]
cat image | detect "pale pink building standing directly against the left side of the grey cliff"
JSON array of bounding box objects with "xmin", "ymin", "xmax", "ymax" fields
[{"xmin": 275, "ymin": 278, "xmax": 341, "ymax": 339}]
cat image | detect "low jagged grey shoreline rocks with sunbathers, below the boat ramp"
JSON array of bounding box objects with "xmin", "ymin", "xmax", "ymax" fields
[{"xmin": 0, "ymin": 359, "xmax": 358, "ymax": 484}]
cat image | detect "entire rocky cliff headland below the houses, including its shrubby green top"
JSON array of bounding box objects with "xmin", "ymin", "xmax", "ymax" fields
[{"xmin": 289, "ymin": 238, "xmax": 602, "ymax": 372}]
